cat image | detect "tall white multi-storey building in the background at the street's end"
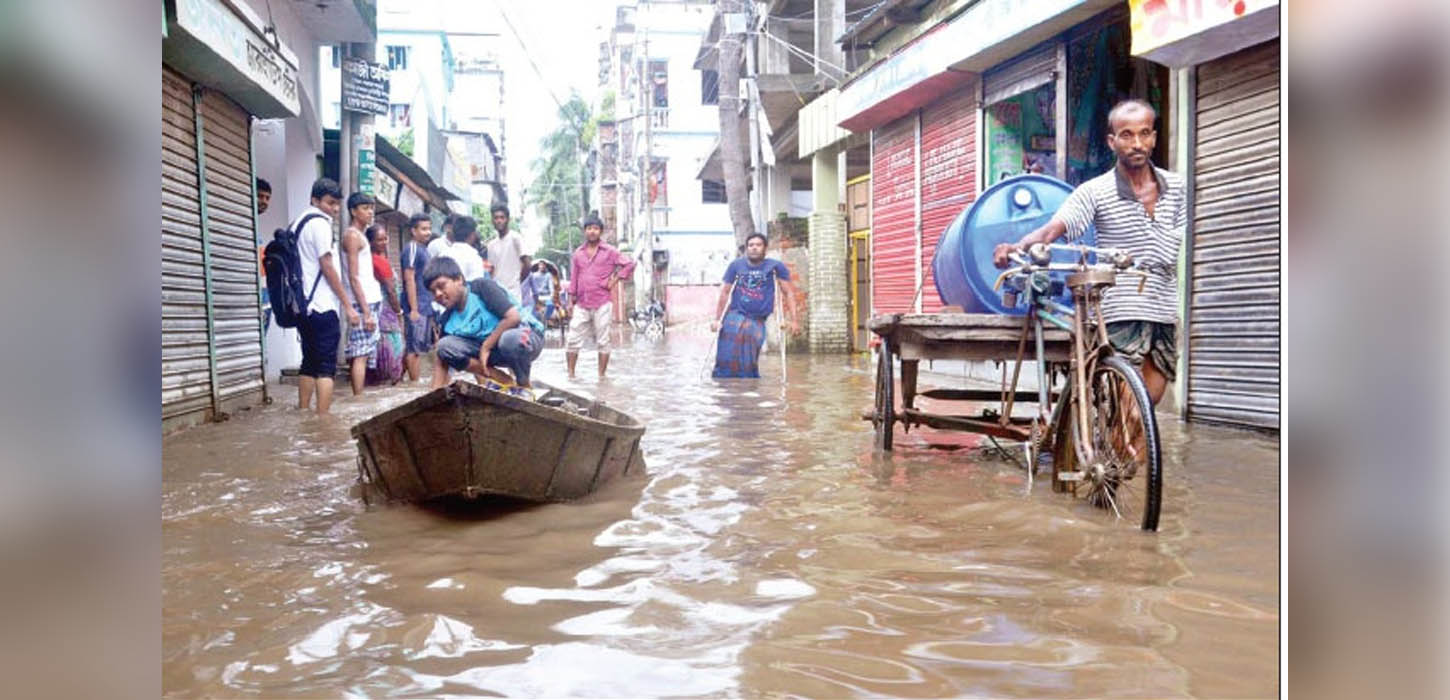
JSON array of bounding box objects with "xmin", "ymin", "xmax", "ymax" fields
[{"xmin": 595, "ymin": 0, "xmax": 737, "ymax": 322}]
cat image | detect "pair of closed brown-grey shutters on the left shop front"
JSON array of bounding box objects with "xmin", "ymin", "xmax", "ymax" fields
[{"xmin": 161, "ymin": 68, "xmax": 262, "ymax": 429}]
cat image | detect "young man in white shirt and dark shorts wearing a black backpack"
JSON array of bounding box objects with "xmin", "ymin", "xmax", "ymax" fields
[{"xmin": 262, "ymin": 177, "xmax": 350, "ymax": 416}]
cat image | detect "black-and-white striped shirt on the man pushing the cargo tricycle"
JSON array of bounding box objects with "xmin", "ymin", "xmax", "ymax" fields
[{"xmin": 1054, "ymin": 167, "xmax": 1188, "ymax": 323}]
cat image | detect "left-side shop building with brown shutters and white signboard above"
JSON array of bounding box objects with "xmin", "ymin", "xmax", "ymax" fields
[{"xmin": 161, "ymin": 0, "xmax": 376, "ymax": 430}]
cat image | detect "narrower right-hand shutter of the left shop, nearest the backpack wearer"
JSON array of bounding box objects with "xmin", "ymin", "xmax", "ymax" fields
[{"xmin": 202, "ymin": 90, "xmax": 262, "ymax": 401}]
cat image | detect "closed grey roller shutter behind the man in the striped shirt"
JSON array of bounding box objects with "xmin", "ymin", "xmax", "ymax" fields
[{"xmin": 1186, "ymin": 41, "xmax": 1280, "ymax": 429}]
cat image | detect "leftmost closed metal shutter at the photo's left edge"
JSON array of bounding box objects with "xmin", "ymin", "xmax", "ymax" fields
[{"xmin": 161, "ymin": 70, "xmax": 212, "ymax": 419}]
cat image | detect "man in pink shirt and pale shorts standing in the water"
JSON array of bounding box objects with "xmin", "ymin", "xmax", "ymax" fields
[{"xmin": 564, "ymin": 214, "xmax": 634, "ymax": 380}]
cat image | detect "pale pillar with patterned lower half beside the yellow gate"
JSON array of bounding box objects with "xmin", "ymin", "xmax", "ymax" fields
[{"xmin": 808, "ymin": 148, "xmax": 851, "ymax": 352}]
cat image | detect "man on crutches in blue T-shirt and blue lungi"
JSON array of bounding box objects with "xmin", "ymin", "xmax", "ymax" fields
[{"xmin": 711, "ymin": 233, "xmax": 800, "ymax": 378}]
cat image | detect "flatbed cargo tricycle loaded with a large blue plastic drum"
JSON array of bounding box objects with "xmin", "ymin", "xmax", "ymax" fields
[{"xmin": 864, "ymin": 174, "xmax": 1163, "ymax": 530}]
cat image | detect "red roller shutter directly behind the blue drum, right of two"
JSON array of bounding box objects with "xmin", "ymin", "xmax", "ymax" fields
[{"xmin": 912, "ymin": 86, "xmax": 977, "ymax": 313}]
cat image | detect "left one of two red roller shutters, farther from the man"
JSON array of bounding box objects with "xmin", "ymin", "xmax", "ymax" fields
[{"xmin": 871, "ymin": 114, "xmax": 916, "ymax": 313}]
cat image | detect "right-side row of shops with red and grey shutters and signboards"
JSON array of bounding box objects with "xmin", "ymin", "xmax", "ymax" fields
[{"xmin": 799, "ymin": 0, "xmax": 1280, "ymax": 428}]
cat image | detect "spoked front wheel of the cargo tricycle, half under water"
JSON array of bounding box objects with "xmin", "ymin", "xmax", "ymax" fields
[{"xmin": 1069, "ymin": 355, "xmax": 1163, "ymax": 530}]
